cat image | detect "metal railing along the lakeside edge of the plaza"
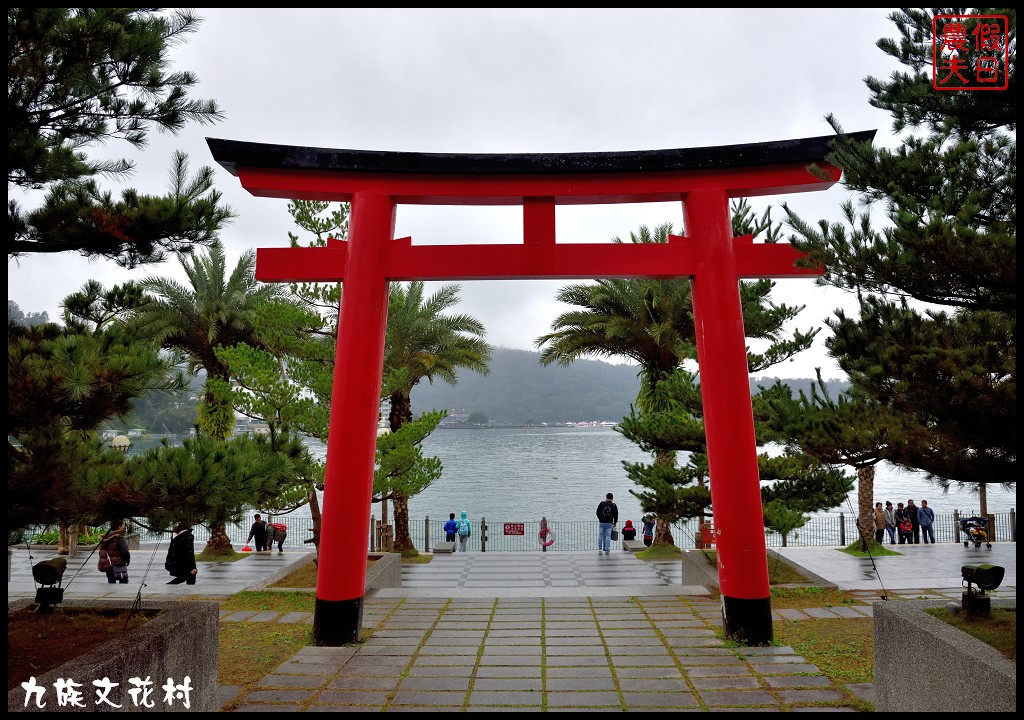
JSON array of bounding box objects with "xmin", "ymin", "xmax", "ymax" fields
[{"xmin": 94, "ymin": 509, "xmax": 1017, "ymax": 552}]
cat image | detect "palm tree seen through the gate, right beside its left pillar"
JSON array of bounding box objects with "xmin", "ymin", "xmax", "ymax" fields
[{"xmin": 384, "ymin": 282, "xmax": 490, "ymax": 551}]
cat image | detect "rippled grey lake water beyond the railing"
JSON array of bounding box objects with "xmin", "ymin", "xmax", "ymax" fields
[{"xmin": 295, "ymin": 427, "xmax": 1017, "ymax": 524}]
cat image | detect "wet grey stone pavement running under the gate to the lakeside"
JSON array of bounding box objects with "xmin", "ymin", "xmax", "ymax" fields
[{"xmin": 8, "ymin": 543, "xmax": 1016, "ymax": 712}]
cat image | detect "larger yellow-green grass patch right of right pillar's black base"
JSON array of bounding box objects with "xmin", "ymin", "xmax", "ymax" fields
[{"xmin": 772, "ymin": 618, "xmax": 872, "ymax": 684}]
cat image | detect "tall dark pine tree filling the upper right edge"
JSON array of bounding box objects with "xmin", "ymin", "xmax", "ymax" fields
[{"xmin": 787, "ymin": 8, "xmax": 1017, "ymax": 511}]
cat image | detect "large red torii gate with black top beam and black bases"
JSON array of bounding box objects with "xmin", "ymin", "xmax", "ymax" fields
[{"xmin": 207, "ymin": 131, "xmax": 874, "ymax": 645}]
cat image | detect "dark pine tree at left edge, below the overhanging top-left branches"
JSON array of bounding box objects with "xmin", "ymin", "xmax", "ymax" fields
[{"xmin": 7, "ymin": 284, "xmax": 183, "ymax": 528}]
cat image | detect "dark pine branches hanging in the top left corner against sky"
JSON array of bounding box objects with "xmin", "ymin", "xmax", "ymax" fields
[{"xmin": 5, "ymin": 7, "xmax": 233, "ymax": 267}]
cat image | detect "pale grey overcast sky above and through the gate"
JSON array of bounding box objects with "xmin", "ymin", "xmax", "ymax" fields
[{"xmin": 7, "ymin": 8, "xmax": 901, "ymax": 378}]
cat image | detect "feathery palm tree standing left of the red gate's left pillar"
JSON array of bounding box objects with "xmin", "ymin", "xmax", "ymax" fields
[{"xmin": 135, "ymin": 242, "xmax": 281, "ymax": 553}]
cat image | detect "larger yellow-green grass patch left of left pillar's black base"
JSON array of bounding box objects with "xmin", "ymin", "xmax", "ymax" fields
[{"xmin": 217, "ymin": 622, "xmax": 312, "ymax": 696}]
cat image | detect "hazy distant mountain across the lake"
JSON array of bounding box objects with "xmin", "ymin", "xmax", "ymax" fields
[{"xmin": 412, "ymin": 347, "xmax": 847, "ymax": 425}]
